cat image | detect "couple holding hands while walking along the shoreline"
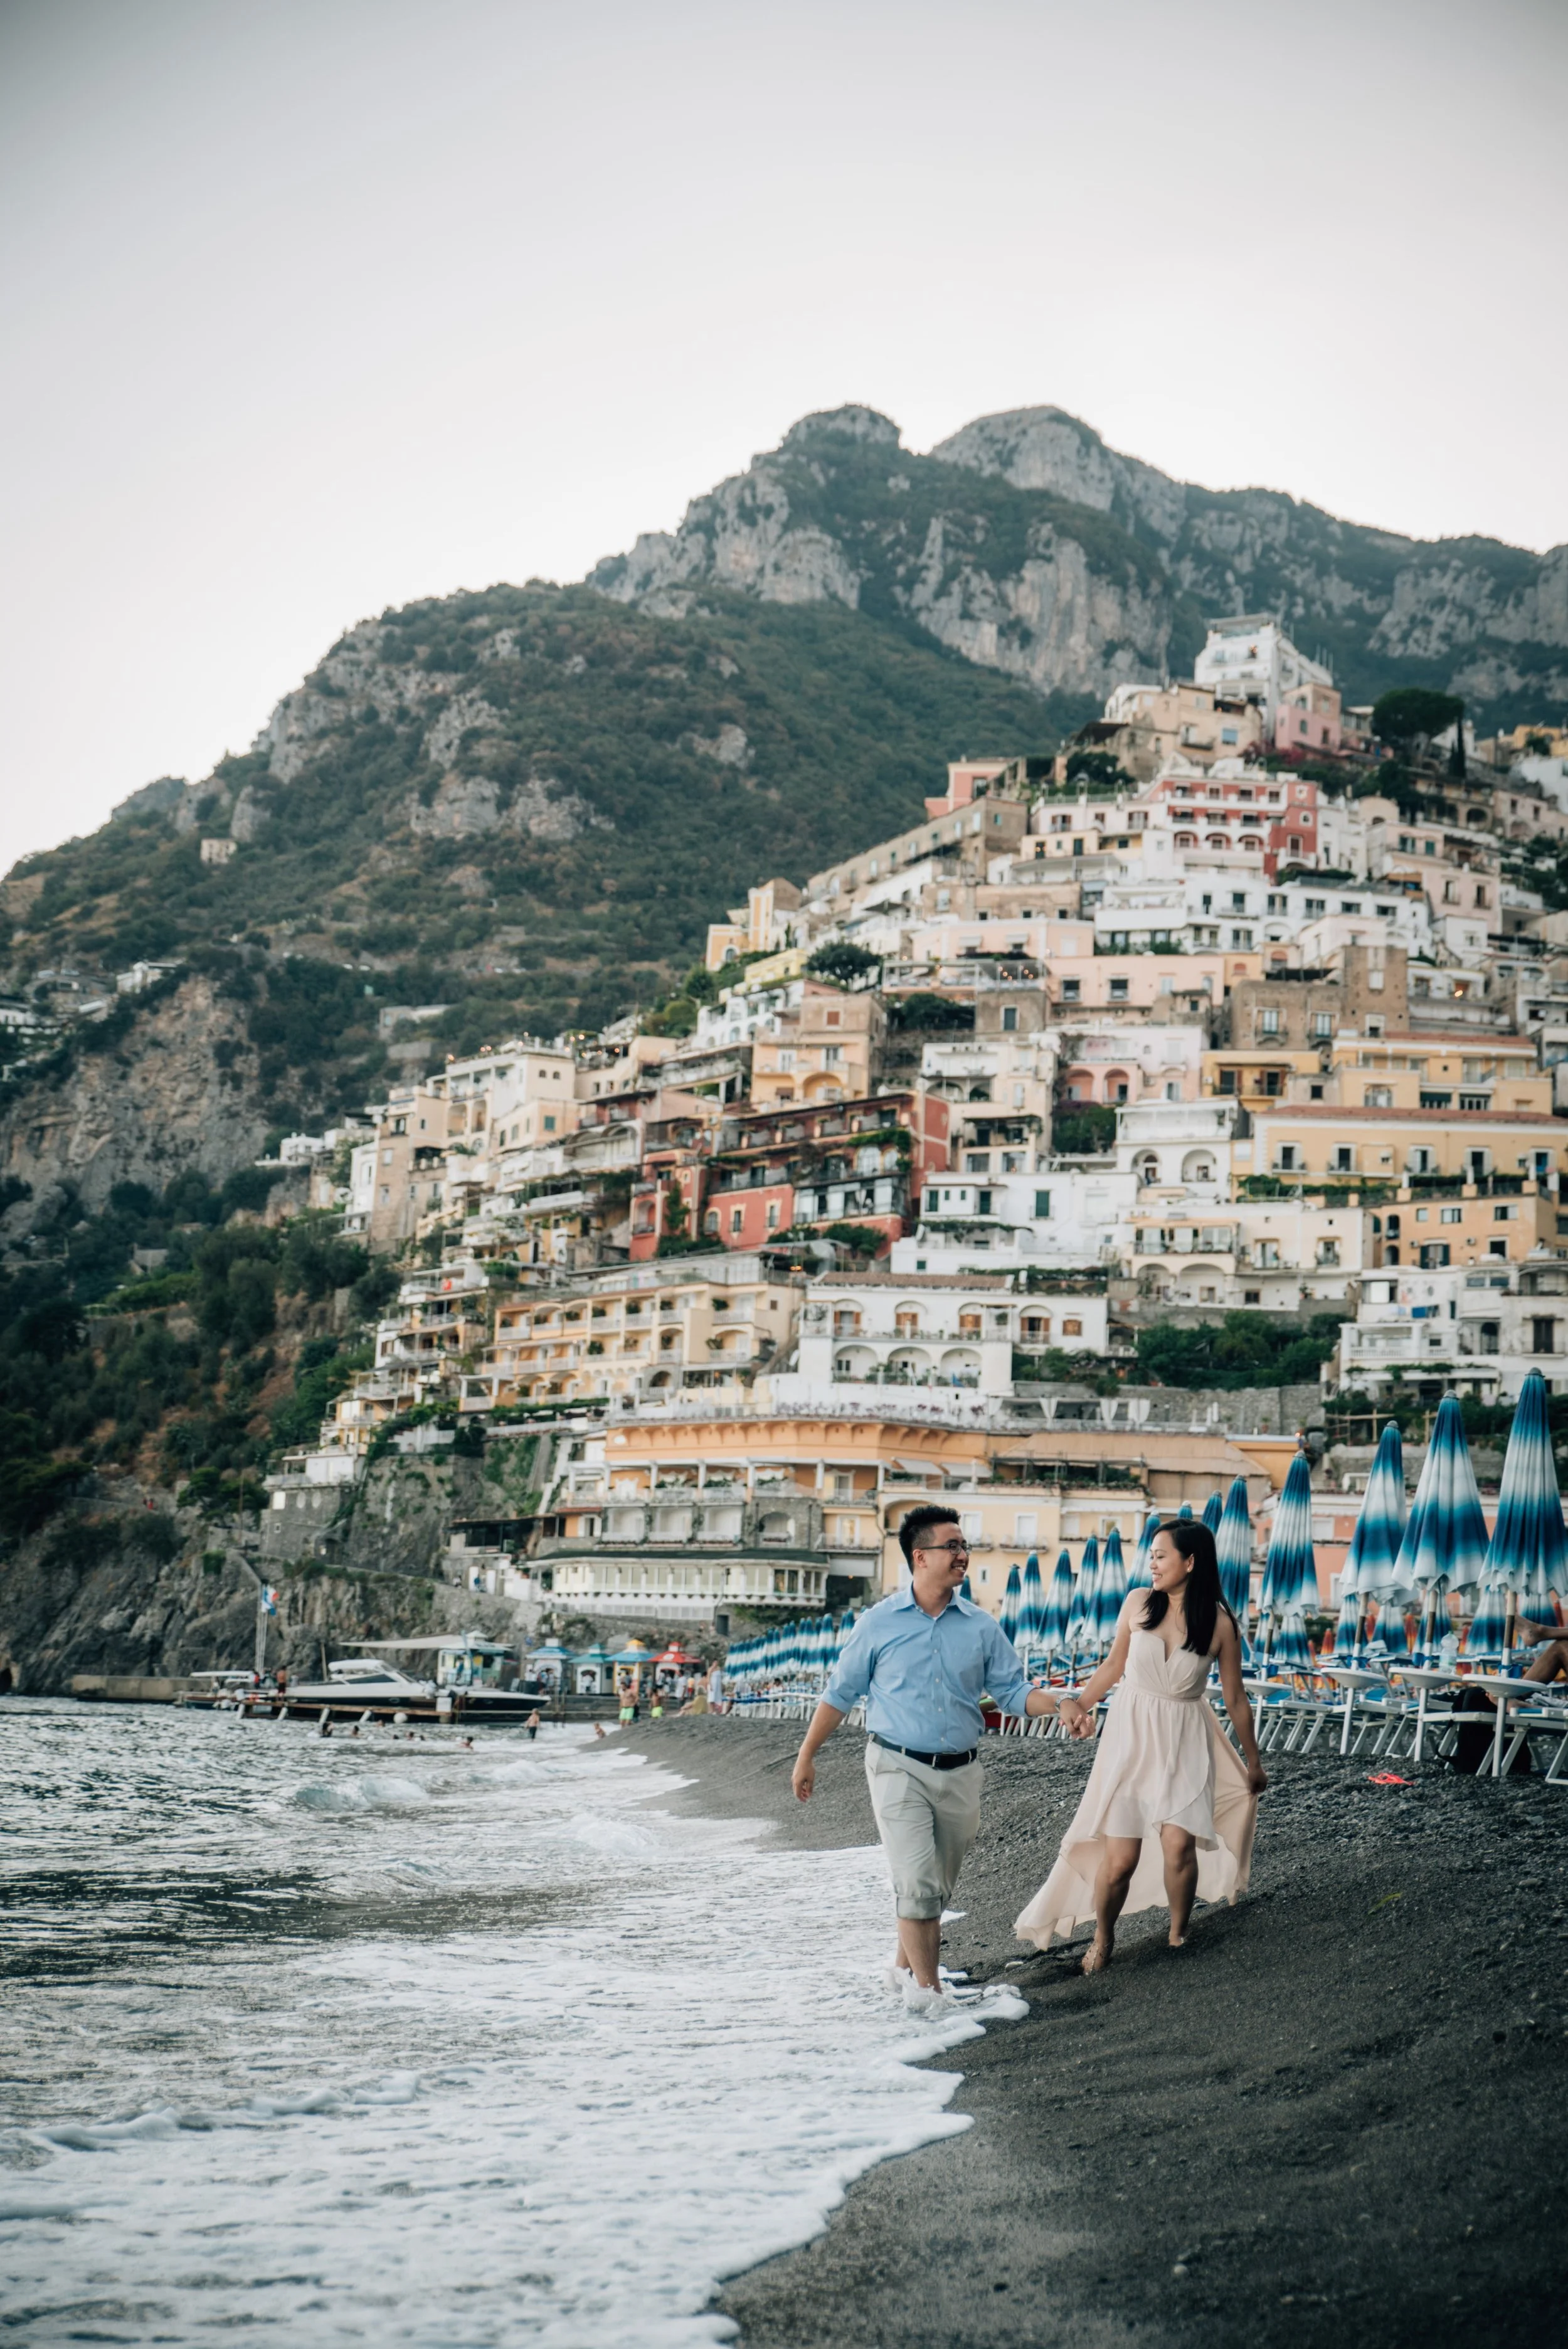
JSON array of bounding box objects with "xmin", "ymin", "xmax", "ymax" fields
[{"xmin": 793, "ymin": 1503, "xmax": 1268, "ymax": 2008}]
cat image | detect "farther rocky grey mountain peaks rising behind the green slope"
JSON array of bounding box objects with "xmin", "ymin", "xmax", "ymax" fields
[{"xmin": 591, "ymin": 406, "xmax": 1568, "ymax": 726}]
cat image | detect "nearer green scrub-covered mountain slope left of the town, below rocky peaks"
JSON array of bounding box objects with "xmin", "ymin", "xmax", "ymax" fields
[{"xmin": 0, "ymin": 585, "xmax": 1056, "ymax": 1229}]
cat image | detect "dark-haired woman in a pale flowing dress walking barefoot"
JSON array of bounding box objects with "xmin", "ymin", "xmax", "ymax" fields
[{"xmin": 1014, "ymin": 1517, "xmax": 1268, "ymax": 1973}]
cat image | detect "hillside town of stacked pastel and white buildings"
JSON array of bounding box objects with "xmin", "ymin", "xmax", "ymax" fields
[{"xmin": 251, "ymin": 615, "xmax": 1568, "ymax": 1630}]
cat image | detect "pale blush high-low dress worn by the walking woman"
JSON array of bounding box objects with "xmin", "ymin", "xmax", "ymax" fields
[{"xmin": 1014, "ymin": 1630, "xmax": 1258, "ymax": 1949}]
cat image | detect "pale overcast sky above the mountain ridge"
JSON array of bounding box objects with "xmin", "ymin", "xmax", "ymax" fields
[{"xmin": 0, "ymin": 0, "xmax": 1568, "ymax": 869}]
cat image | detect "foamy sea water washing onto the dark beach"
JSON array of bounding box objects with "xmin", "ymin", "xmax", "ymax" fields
[{"xmin": 0, "ymin": 1699, "xmax": 1024, "ymax": 2349}]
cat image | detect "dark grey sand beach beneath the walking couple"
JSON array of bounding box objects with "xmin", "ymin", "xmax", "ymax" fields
[{"xmin": 632, "ymin": 1719, "xmax": 1568, "ymax": 2349}]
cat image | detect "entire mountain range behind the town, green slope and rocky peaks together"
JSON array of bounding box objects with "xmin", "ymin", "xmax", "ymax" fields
[{"xmin": 0, "ymin": 406, "xmax": 1568, "ymax": 1233}]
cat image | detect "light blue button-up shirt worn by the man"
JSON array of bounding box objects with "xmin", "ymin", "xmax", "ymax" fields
[{"xmin": 822, "ymin": 1590, "xmax": 1028, "ymax": 1755}]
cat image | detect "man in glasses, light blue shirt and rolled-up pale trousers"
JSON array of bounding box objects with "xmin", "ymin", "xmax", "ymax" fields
[{"xmin": 793, "ymin": 1503, "xmax": 1056, "ymax": 2006}]
